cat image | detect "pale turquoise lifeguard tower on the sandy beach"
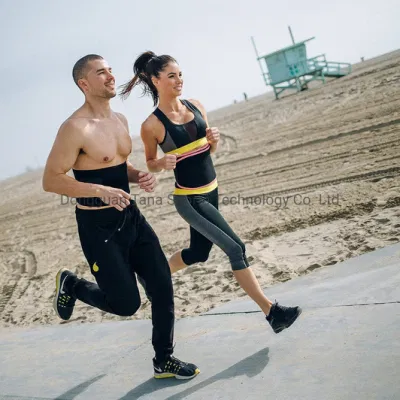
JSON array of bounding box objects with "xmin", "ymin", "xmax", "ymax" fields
[{"xmin": 251, "ymin": 26, "xmax": 351, "ymax": 99}]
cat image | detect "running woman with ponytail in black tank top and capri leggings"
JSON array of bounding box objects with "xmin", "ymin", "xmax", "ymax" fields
[{"xmin": 120, "ymin": 51, "xmax": 302, "ymax": 333}]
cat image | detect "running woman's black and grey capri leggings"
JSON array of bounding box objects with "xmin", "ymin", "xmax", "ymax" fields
[{"xmin": 174, "ymin": 188, "xmax": 249, "ymax": 271}]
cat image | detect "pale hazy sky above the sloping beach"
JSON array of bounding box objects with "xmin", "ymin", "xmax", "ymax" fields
[{"xmin": 0, "ymin": 0, "xmax": 400, "ymax": 180}]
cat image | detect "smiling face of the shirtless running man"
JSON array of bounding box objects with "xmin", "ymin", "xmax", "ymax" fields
[{"xmin": 81, "ymin": 60, "xmax": 117, "ymax": 99}]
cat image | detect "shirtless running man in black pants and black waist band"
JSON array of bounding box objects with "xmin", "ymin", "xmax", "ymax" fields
[{"xmin": 43, "ymin": 54, "xmax": 200, "ymax": 379}]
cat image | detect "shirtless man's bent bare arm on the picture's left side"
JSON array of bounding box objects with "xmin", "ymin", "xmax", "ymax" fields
[{"xmin": 42, "ymin": 120, "xmax": 102, "ymax": 198}]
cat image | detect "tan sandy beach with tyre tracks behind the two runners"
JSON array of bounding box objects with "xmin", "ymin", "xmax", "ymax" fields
[{"xmin": 0, "ymin": 50, "xmax": 400, "ymax": 328}]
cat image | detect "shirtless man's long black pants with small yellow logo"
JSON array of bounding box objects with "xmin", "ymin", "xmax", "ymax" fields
[{"xmin": 74, "ymin": 200, "xmax": 174, "ymax": 361}]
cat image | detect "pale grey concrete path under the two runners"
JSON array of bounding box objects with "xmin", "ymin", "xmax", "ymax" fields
[{"xmin": 0, "ymin": 245, "xmax": 400, "ymax": 400}]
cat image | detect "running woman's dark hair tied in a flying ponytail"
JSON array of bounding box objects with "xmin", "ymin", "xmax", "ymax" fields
[{"xmin": 119, "ymin": 51, "xmax": 176, "ymax": 106}]
